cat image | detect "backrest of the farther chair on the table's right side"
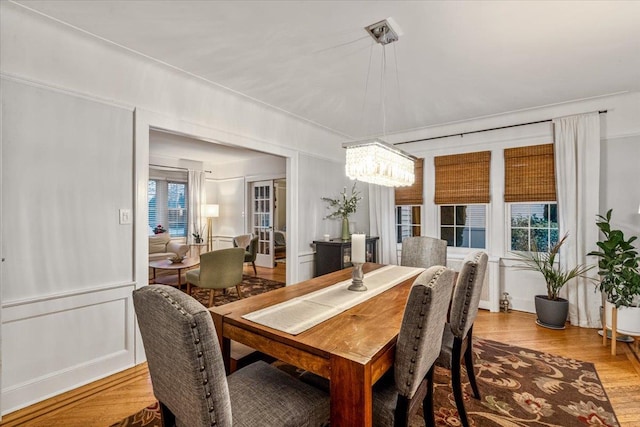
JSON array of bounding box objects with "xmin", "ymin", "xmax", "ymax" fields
[{"xmin": 449, "ymin": 251, "xmax": 489, "ymax": 339}]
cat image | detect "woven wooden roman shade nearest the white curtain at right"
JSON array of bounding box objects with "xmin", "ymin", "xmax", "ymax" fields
[{"xmin": 504, "ymin": 144, "xmax": 556, "ymax": 202}]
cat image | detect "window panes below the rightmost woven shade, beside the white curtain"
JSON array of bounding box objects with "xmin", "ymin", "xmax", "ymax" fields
[{"xmin": 510, "ymin": 203, "xmax": 559, "ymax": 252}]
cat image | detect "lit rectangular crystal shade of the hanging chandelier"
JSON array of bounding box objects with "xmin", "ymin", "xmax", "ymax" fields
[{"xmin": 344, "ymin": 139, "xmax": 415, "ymax": 187}]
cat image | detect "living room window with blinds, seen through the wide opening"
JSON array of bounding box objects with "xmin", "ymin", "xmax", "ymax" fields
[{"xmin": 147, "ymin": 179, "xmax": 188, "ymax": 237}]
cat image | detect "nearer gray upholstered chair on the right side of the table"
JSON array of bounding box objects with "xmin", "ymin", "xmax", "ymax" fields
[{"xmin": 373, "ymin": 266, "xmax": 454, "ymax": 426}]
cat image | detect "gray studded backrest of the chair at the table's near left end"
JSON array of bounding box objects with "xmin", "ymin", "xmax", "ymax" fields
[{"xmin": 133, "ymin": 285, "xmax": 232, "ymax": 426}]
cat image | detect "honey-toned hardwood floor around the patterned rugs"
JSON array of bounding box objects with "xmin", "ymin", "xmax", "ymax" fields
[{"xmin": 0, "ymin": 265, "xmax": 640, "ymax": 427}]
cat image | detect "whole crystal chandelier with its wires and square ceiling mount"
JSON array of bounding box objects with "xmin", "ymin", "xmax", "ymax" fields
[{"xmin": 342, "ymin": 18, "xmax": 415, "ymax": 187}]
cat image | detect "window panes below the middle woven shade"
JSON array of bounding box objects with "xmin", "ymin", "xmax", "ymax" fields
[{"xmin": 440, "ymin": 205, "xmax": 487, "ymax": 249}]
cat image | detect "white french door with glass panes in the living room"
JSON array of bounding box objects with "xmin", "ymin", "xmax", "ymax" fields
[{"xmin": 251, "ymin": 181, "xmax": 273, "ymax": 268}]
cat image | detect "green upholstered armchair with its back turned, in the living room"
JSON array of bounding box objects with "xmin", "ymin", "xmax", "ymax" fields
[{"xmin": 185, "ymin": 248, "xmax": 244, "ymax": 307}]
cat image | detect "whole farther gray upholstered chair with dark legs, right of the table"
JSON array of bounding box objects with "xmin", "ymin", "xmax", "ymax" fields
[{"xmin": 436, "ymin": 251, "xmax": 488, "ymax": 427}]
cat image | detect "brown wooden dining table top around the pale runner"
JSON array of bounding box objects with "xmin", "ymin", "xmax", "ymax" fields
[{"xmin": 209, "ymin": 263, "xmax": 417, "ymax": 380}]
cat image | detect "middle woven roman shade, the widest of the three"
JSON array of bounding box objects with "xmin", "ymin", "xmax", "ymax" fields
[{"xmin": 434, "ymin": 151, "xmax": 491, "ymax": 205}]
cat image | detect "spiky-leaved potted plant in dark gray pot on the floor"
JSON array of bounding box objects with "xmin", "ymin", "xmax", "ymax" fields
[{"xmin": 514, "ymin": 234, "xmax": 594, "ymax": 329}]
